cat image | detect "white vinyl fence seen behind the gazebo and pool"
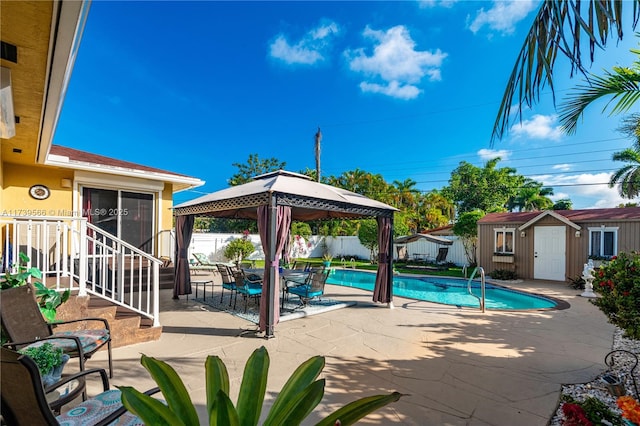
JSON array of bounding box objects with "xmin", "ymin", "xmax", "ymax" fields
[{"xmin": 189, "ymin": 232, "xmax": 467, "ymax": 266}]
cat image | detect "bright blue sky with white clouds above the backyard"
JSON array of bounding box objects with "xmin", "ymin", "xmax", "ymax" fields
[{"xmin": 54, "ymin": 0, "xmax": 638, "ymax": 208}]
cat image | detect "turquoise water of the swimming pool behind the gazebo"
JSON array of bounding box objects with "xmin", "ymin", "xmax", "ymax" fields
[{"xmin": 327, "ymin": 269, "xmax": 557, "ymax": 310}]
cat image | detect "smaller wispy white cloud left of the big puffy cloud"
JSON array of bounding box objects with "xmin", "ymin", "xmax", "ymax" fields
[{"xmin": 269, "ymin": 22, "xmax": 340, "ymax": 65}]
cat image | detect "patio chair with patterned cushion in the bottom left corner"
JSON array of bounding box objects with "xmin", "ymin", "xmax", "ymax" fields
[{"xmin": 0, "ymin": 348, "xmax": 159, "ymax": 425}]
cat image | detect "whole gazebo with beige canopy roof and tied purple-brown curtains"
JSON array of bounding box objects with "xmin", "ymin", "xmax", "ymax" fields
[{"xmin": 173, "ymin": 170, "xmax": 397, "ymax": 338}]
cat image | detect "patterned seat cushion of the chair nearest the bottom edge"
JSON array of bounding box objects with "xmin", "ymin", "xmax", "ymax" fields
[{"xmin": 56, "ymin": 389, "xmax": 144, "ymax": 426}]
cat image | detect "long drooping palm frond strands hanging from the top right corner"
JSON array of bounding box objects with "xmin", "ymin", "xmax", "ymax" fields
[{"xmin": 491, "ymin": 0, "xmax": 640, "ymax": 143}]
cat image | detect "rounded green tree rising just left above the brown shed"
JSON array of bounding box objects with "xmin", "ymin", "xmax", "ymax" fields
[{"xmin": 442, "ymin": 157, "xmax": 524, "ymax": 214}]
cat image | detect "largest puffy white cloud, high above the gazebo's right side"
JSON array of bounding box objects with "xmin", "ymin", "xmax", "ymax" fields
[{"xmin": 345, "ymin": 25, "xmax": 447, "ymax": 99}]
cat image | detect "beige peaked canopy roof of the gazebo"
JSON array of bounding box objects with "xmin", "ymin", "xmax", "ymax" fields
[{"xmin": 174, "ymin": 170, "xmax": 397, "ymax": 221}]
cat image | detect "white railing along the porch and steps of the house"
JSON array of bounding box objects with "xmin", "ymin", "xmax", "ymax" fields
[{"xmin": 0, "ymin": 216, "xmax": 162, "ymax": 326}]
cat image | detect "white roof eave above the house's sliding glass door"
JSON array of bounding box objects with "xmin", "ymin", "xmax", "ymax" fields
[{"xmin": 45, "ymin": 154, "xmax": 205, "ymax": 193}]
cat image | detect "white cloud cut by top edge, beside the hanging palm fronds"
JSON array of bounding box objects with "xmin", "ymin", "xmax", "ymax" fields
[{"xmin": 469, "ymin": 0, "xmax": 538, "ymax": 34}]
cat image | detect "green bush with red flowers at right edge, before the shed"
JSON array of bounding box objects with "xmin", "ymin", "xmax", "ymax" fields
[{"xmin": 590, "ymin": 251, "xmax": 640, "ymax": 339}]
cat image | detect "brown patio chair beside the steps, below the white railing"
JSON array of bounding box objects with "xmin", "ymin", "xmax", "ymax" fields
[{"xmin": 0, "ymin": 284, "xmax": 113, "ymax": 377}]
